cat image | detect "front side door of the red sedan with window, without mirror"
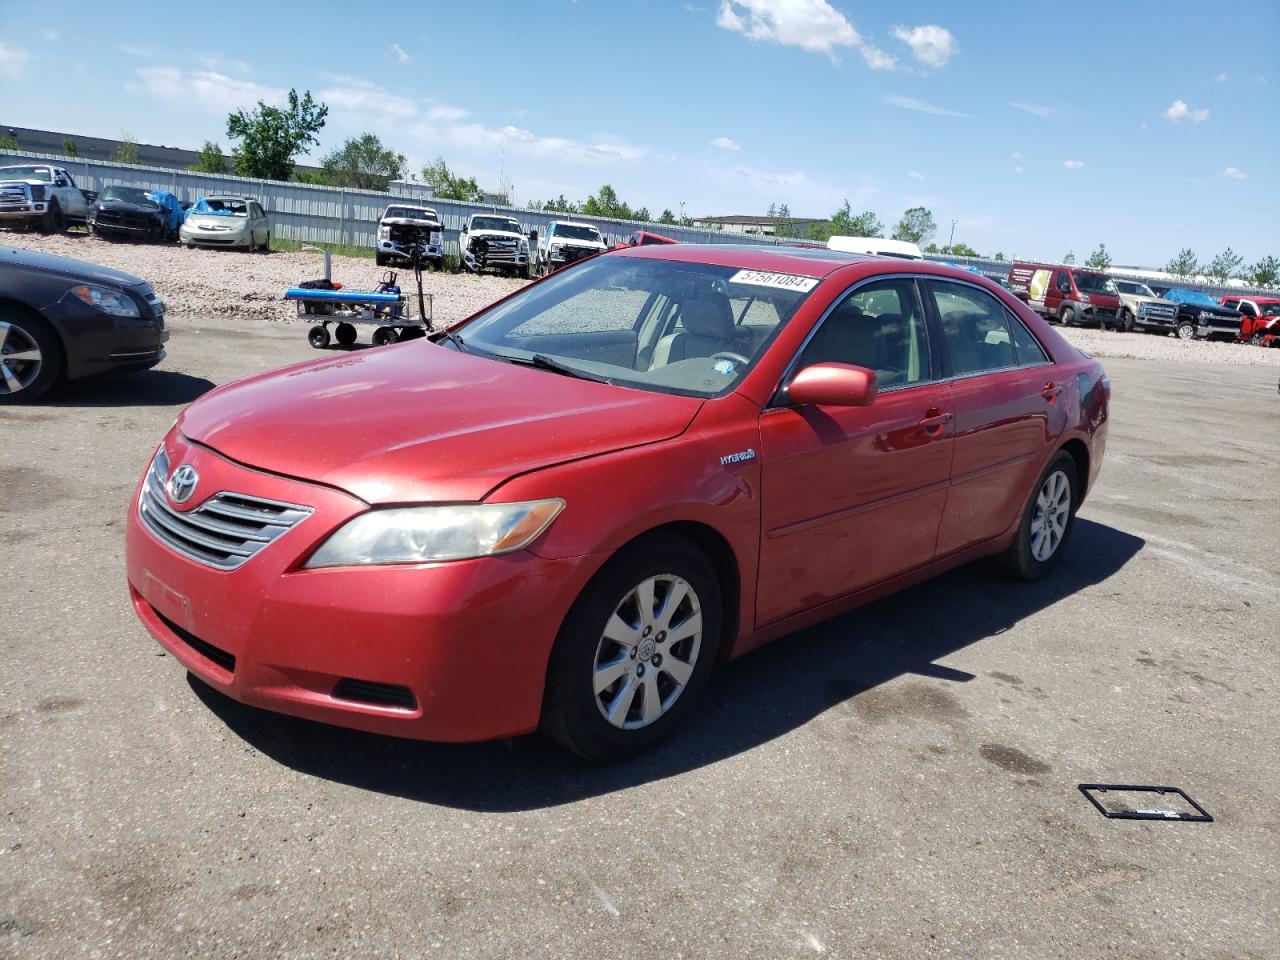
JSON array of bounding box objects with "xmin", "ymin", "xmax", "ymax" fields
[{"xmin": 756, "ymin": 278, "xmax": 952, "ymax": 626}]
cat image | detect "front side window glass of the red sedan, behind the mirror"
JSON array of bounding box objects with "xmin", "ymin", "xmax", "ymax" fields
[{"xmin": 796, "ymin": 279, "xmax": 933, "ymax": 389}]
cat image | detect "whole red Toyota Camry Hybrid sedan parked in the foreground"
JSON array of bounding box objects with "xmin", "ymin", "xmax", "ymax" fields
[{"xmin": 128, "ymin": 244, "xmax": 1110, "ymax": 760}]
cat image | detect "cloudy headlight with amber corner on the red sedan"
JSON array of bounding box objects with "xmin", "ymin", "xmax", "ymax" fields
[{"xmin": 306, "ymin": 499, "xmax": 564, "ymax": 567}]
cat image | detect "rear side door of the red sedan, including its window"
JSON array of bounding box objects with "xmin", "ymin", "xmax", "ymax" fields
[{"xmin": 924, "ymin": 280, "xmax": 1066, "ymax": 557}]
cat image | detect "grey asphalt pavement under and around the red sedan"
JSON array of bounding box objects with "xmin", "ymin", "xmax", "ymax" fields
[{"xmin": 0, "ymin": 319, "xmax": 1280, "ymax": 960}]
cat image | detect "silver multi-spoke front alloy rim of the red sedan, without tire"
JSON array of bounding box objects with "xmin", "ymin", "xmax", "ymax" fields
[{"xmin": 591, "ymin": 575, "xmax": 703, "ymax": 730}]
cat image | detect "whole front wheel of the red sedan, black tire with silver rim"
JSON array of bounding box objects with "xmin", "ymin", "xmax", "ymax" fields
[{"xmin": 541, "ymin": 535, "xmax": 722, "ymax": 763}]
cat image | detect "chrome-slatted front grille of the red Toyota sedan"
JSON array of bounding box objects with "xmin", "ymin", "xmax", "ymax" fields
[{"xmin": 138, "ymin": 448, "xmax": 312, "ymax": 570}]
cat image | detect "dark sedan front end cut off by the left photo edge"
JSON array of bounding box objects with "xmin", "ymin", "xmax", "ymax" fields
[{"xmin": 0, "ymin": 247, "xmax": 169, "ymax": 403}]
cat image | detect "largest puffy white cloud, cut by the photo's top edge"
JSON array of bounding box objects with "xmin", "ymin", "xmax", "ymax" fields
[{"xmin": 716, "ymin": 0, "xmax": 897, "ymax": 70}]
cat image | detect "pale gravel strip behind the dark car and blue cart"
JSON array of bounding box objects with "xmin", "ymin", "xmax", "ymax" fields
[{"xmin": 0, "ymin": 233, "xmax": 522, "ymax": 324}]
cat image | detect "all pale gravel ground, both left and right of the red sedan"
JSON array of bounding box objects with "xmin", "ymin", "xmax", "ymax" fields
[{"xmin": 0, "ymin": 233, "xmax": 1280, "ymax": 366}]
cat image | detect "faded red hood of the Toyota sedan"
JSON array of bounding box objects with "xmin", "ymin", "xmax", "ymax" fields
[{"xmin": 178, "ymin": 348, "xmax": 703, "ymax": 512}]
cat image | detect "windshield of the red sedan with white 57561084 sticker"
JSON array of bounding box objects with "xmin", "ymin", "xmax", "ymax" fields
[{"xmin": 457, "ymin": 256, "xmax": 818, "ymax": 397}]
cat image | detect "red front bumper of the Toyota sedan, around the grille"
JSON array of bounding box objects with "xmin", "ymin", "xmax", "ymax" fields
[{"xmin": 125, "ymin": 431, "xmax": 593, "ymax": 741}]
